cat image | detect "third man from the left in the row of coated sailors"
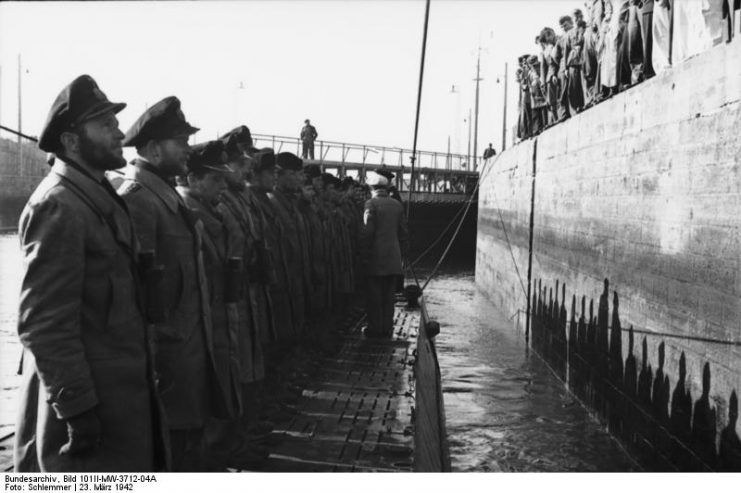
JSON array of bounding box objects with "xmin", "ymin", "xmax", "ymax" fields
[{"xmin": 177, "ymin": 140, "xmax": 262, "ymax": 470}]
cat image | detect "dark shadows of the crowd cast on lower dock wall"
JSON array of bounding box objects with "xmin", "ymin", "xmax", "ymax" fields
[{"xmin": 530, "ymin": 279, "xmax": 741, "ymax": 471}]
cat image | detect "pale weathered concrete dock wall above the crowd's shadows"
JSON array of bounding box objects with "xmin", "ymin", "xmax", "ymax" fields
[{"xmin": 476, "ymin": 39, "xmax": 741, "ymax": 468}]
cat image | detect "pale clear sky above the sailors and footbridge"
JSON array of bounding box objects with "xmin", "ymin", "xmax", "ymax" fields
[{"xmin": 0, "ymin": 0, "xmax": 572, "ymax": 158}]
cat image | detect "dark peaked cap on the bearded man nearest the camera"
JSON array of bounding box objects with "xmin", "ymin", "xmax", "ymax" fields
[{"xmin": 39, "ymin": 75, "xmax": 126, "ymax": 152}]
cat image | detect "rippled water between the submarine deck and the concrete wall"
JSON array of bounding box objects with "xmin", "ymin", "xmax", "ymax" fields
[{"xmin": 425, "ymin": 272, "xmax": 640, "ymax": 472}]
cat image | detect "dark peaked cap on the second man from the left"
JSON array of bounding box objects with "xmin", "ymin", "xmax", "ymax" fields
[{"xmin": 123, "ymin": 96, "xmax": 199, "ymax": 147}]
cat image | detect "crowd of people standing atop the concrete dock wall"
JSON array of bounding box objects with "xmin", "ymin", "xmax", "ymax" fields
[{"xmin": 515, "ymin": 0, "xmax": 741, "ymax": 140}]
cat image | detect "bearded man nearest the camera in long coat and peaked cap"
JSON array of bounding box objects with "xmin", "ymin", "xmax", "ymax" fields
[{"xmin": 14, "ymin": 75, "xmax": 165, "ymax": 472}]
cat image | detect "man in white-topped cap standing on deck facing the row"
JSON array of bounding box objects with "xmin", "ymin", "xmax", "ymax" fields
[{"xmin": 361, "ymin": 173, "xmax": 409, "ymax": 337}]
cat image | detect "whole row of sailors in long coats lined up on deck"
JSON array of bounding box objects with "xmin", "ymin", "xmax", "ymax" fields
[{"xmin": 14, "ymin": 76, "xmax": 367, "ymax": 472}]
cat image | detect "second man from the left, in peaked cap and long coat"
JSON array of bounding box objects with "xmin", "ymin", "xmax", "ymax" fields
[{"xmin": 119, "ymin": 96, "xmax": 224, "ymax": 471}]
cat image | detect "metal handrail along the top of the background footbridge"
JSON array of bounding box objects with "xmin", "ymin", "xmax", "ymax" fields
[{"xmin": 252, "ymin": 134, "xmax": 480, "ymax": 171}]
